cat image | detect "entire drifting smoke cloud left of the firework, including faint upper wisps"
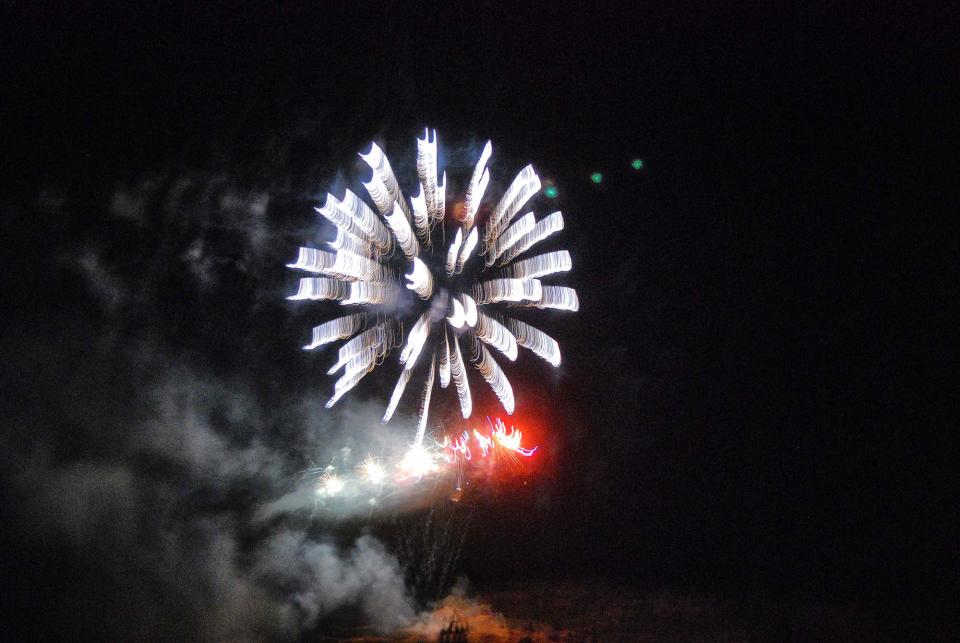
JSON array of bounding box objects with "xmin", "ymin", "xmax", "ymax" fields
[{"xmin": 0, "ymin": 156, "xmax": 432, "ymax": 640}]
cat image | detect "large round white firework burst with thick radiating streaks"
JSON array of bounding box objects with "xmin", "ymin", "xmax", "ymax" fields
[{"xmin": 288, "ymin": 130, "xmax": 580, "ymax": 442}]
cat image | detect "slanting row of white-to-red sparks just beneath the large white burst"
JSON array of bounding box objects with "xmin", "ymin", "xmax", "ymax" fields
[{"xmin": 316, "ymin": 418, "xmax": 539, "ymax": 504}]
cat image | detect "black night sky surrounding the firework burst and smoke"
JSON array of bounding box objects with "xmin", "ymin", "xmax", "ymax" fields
[{"xmin": 0, "ymin": 3, "xmax": 960, "ymax": 635}]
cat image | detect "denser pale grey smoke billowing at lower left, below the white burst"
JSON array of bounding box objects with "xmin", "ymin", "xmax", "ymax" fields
[{"xmin": 4, "ymin": 352, "xmax": 414, "ymax": 640}]
